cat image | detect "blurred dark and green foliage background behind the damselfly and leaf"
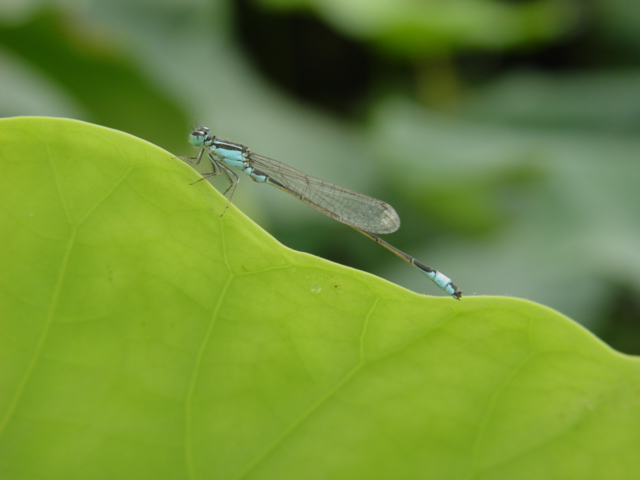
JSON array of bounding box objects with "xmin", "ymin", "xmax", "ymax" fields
[{"xmin": 0, "ymin": 0, "xmax": 640, "ymax": 354}]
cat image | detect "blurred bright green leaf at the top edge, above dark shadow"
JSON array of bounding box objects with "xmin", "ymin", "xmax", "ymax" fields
[{"xmin": 252, "ymin": 0, "xmax": 578, "ymax": 58}]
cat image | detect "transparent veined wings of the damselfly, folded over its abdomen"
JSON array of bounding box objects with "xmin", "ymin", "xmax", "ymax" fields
[{"xmin": 248, "ymin": 153, "xmax": 400, "ymax": 233}]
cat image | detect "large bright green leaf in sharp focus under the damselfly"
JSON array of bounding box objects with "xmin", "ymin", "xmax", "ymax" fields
[{"xmin": 0, "ymin": 118, "xmax": 640, "ymax": 480}]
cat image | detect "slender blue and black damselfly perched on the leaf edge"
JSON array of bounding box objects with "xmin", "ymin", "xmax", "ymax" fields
[{"xmin": 180, "ymin": 127, "xmax": 462, "ymax": 300}]
